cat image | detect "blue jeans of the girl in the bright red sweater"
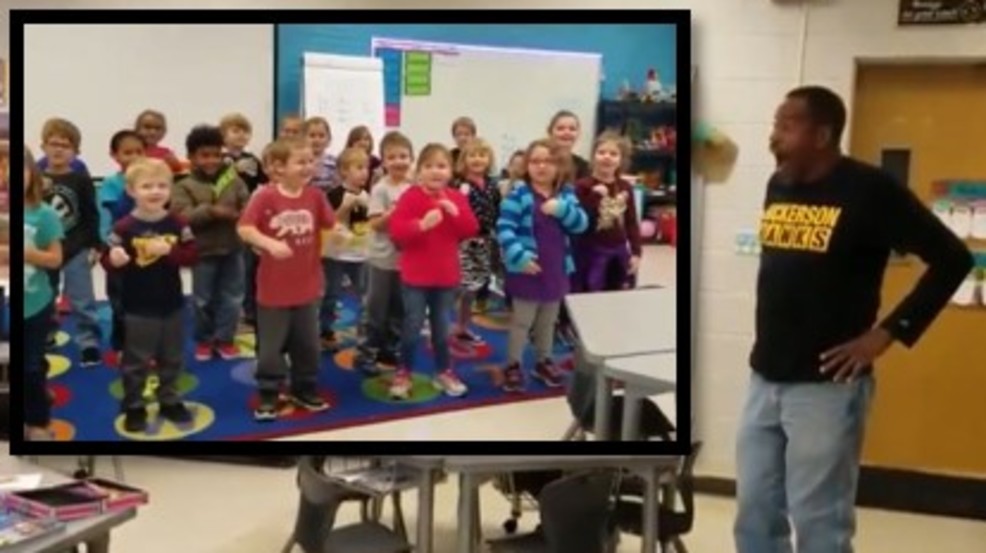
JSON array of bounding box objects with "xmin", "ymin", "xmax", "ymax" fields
[{"xmin": 401, "ymin": 284, "xmax": 458, "ymax": 371}]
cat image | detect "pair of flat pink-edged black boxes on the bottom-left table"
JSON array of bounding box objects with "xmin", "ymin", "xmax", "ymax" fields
[{"xmin": 3, "ymin": 478, "xmax": 148, "ymax": 521}]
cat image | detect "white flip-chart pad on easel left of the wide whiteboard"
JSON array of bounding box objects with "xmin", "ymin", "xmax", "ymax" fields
[{"xmin": 301, "ymin": 52, "xmax": 384, "ymax": 156}]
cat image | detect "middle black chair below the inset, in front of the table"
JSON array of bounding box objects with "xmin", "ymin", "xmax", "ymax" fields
[{"xmin": 489, "ymin": 471, "xmax": 619, "ymax": 553}]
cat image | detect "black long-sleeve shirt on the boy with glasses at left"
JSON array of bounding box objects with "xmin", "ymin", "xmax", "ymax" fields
[{"xmin": 44, "ymin": 171, "xmax": 103, "ymax": 262}]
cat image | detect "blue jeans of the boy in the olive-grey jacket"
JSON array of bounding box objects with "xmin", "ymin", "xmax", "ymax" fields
[{"xmin": 192, "ymin": 250, "xmax": 244, "ymax": 344}]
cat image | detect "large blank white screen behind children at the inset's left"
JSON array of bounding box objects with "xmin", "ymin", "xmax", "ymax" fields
[{"xmin": 24, "ymin": 24, "xmax": 274, "ymax": 176}]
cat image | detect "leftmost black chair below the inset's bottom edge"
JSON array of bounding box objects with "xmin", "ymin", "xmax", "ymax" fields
[{"xmin": 282, "ymin": 456, "xmax": 412, "ymax": 553}]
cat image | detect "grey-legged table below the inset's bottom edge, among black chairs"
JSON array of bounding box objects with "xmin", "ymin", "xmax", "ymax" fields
[{"xmin": 387, "ymin": 455, "xmax": 679, "ymax": 553}]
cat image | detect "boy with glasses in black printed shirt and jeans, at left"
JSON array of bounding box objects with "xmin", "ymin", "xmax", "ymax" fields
[{"xmin": 41, "ymin": 119, "xmax": 103, "ymax": 367}]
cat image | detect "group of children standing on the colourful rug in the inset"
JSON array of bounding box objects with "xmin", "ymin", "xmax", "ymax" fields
[{"xmin": 24, "ymin": 105, "xmax": 641, "ymax": 439}]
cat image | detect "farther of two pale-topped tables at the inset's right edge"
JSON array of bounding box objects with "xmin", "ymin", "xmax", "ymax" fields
[{"xmin": 565, "ymin": 287, "xmax": 678, "ymax": 440}]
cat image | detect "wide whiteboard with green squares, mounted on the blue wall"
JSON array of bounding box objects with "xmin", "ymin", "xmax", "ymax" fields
[{"xmin": 372, "ymin": 37, "xmax": 602, "ymax": 166}]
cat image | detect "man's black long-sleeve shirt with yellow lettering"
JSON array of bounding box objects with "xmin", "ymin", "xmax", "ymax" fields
[{"xmin": 750, "ymin": 158, "xmax": 973, "ymax": 382}]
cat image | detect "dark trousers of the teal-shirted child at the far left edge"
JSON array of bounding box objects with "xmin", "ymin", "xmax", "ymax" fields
[{"xmin": 23, "ymin": 303, "xmax": 55, "ymax": 427}]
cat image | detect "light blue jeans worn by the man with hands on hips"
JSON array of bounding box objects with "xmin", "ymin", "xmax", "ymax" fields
[{"xmin": 733, "ymin": 373, "xmax": 875, "ymax": 553}]
